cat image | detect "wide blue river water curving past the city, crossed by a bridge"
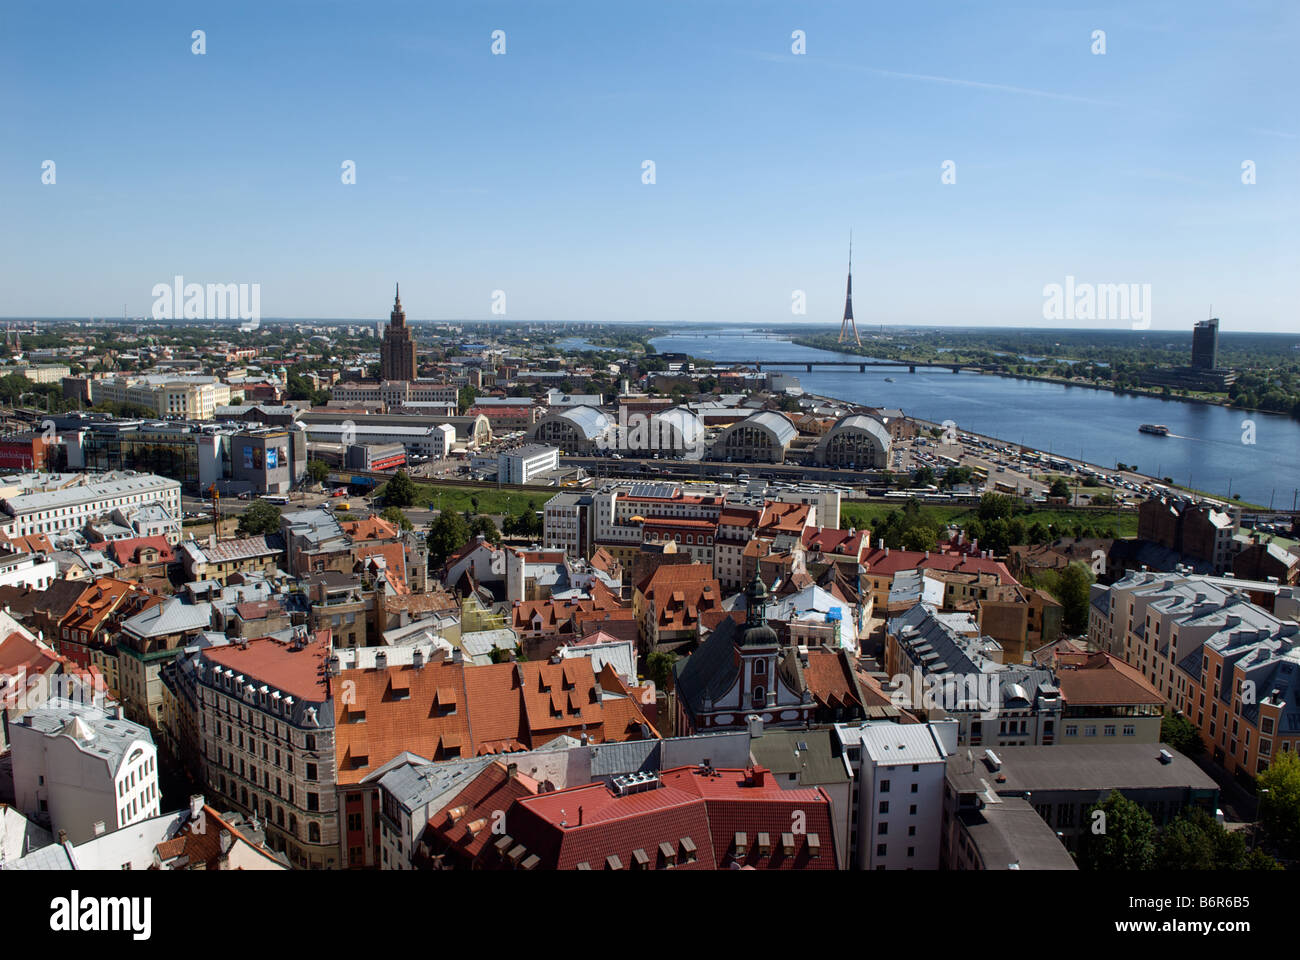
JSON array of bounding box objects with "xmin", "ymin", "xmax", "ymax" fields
[{"xmin": 651, "ymin": 327, "xmax": 1300, "ymax": 510}]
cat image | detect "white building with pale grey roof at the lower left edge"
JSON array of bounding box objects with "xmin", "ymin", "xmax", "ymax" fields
[{"xmin": 9, "ymin": 700, "xmax": 160, "ymax": 843}]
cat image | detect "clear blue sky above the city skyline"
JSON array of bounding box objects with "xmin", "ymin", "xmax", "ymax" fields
[{"xmin": 0, "ymin": 0, "xmax": 1300, "ymax": 330}]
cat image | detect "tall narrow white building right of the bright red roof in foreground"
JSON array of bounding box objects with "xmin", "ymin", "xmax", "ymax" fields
[{"xmin": 835, "ymin": 721, "xmax": 957, "ymax": 870}]
